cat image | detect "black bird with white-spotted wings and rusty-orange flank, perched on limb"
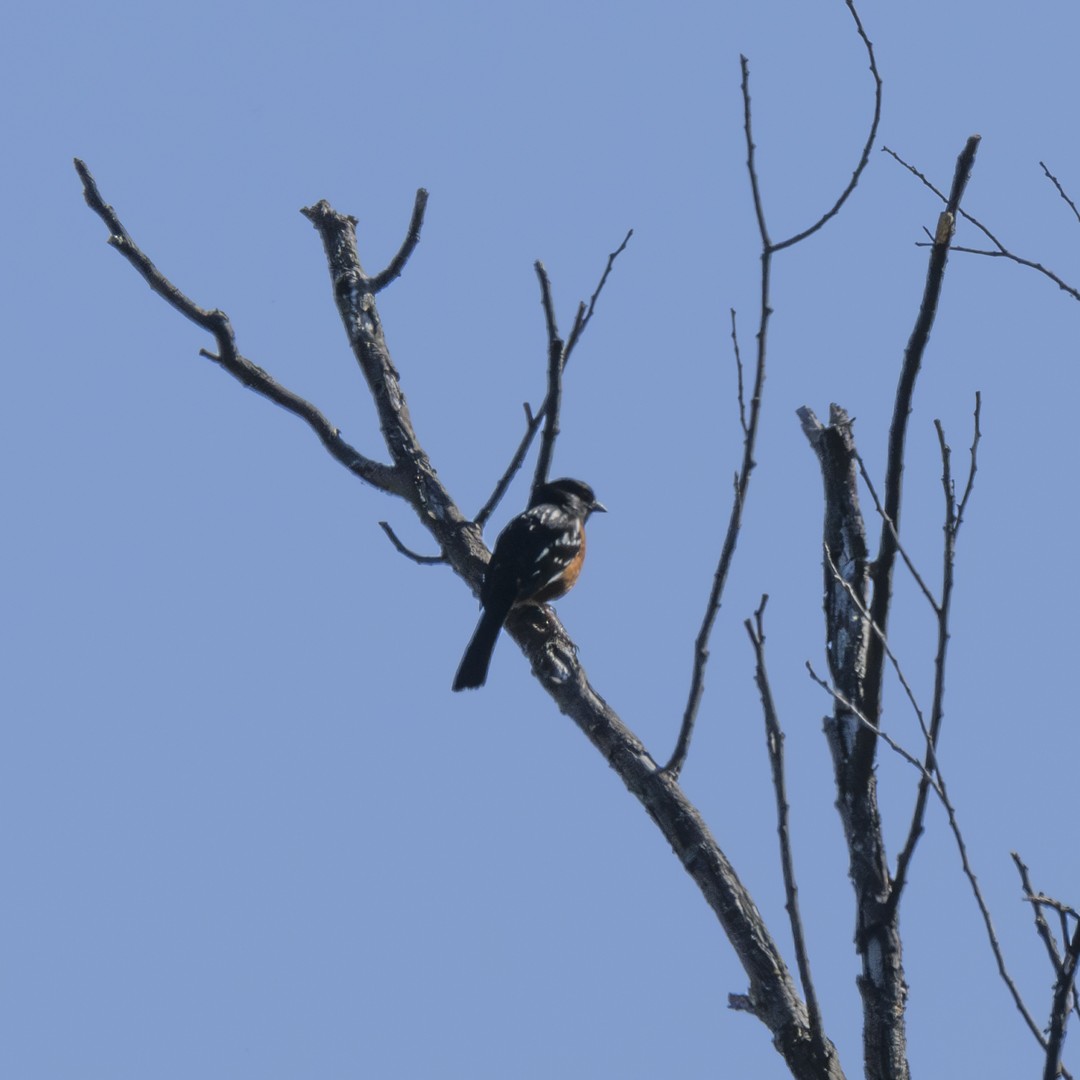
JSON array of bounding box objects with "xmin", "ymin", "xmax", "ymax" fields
[{"xmin": 454, "ymin": 480, "xmax": 607, "ymax": 690}]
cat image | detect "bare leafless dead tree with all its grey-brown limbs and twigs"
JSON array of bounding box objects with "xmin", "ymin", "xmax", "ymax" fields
[{"xmin": 76, "ymin": 0, "xmax": 1080, "ymax": 1080}]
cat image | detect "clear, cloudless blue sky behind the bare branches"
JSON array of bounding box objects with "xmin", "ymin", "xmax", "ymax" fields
[{"xmin": 0, "ymin": 0, "xmax": 1080, "ymax": 1080}]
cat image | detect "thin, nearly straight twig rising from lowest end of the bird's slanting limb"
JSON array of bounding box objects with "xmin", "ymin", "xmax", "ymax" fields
[{"xmin": 743, "ymin": 595, "xmax": 825, "ymax": 1056}]
